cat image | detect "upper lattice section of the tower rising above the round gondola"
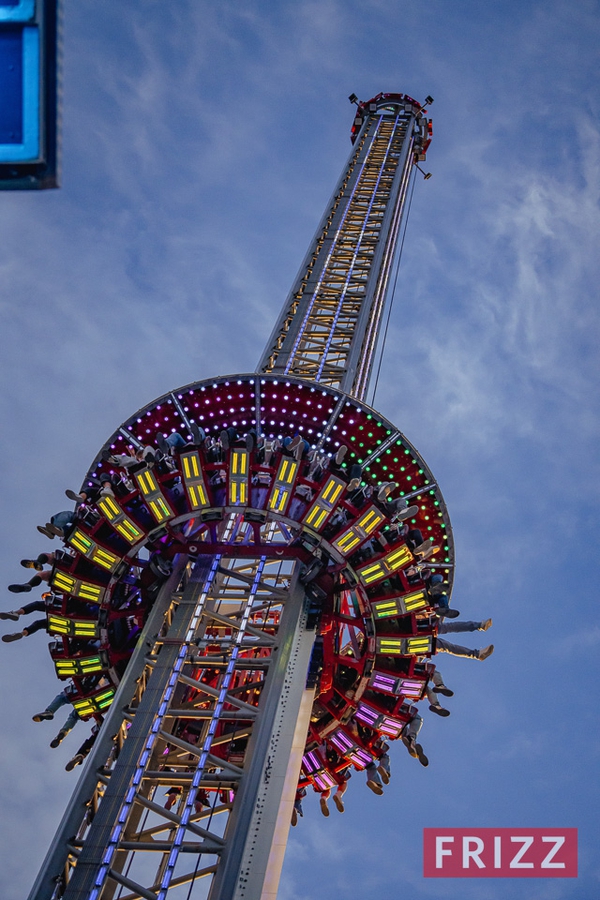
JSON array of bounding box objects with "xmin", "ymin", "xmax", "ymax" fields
[{"xmin": 259, "ymin": 96, "xmax": 426, "ymax": 399}]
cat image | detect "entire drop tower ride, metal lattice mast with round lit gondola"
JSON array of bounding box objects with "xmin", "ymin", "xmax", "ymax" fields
[{"xmin": 25, "ymin": 94, "xmax": 453, "ymax": 900}]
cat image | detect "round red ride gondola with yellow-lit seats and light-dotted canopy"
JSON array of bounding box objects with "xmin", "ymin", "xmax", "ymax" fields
[{"xmin": 49, "ymin": 374, "xmax": 453, "ymax": 790}]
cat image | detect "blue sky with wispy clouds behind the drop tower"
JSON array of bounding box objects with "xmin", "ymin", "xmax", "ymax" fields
[{"xmin": 0, "ymin": 0, "xmax": 600, "ymax": 900}]
